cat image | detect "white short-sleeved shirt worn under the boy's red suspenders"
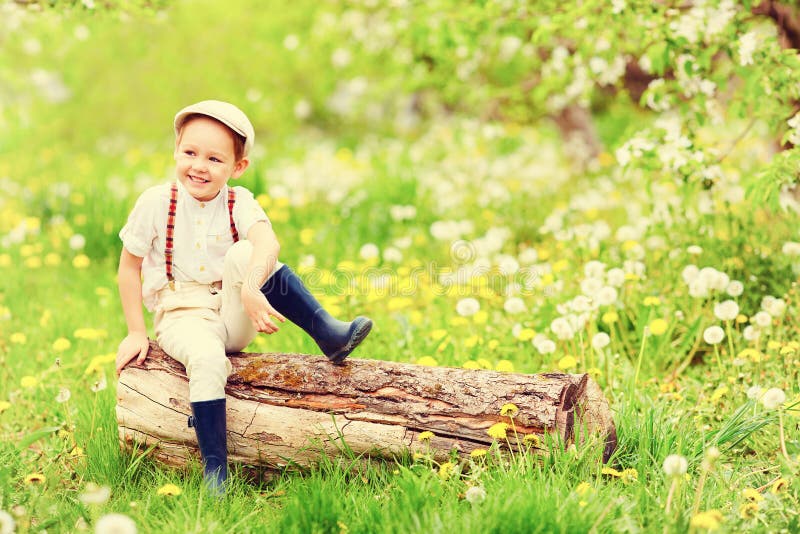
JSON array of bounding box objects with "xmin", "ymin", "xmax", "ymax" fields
[{"xmin": 119, "ymin": 182, "xmax": 269, "ymax": 312}]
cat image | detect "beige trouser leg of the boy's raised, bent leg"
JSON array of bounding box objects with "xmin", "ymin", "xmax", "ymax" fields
[{"xmin": 220, "ymin": 239, "xmax": 281, "ymax": 352}]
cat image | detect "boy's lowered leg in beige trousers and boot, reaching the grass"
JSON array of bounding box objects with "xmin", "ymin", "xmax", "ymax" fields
[{"xmin": 156, "ymin": 310, "xmax": 231, "ymax": 496}]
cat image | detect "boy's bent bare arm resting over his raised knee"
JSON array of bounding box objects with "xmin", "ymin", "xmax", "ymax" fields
[{"xmin": 242, "ymin": 221, "xmax": 286, "ymax": 334}]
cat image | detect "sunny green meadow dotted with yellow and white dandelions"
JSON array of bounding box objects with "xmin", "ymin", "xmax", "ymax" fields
[{"xmin": 0, "ymin": 1, "xmax": 800, "ymax": 534}]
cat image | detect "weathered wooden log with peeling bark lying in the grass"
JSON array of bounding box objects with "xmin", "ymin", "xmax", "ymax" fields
[{"xmin": 116, "ymin": 342, "xmax": 617, "ymax": 474}]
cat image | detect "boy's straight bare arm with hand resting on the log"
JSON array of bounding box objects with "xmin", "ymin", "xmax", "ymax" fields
[{"xmin": 117, "ymin": 247, "xmax": 150, "ymax": 376}]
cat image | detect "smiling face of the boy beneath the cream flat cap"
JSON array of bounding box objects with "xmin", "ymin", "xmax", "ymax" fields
[{"xmin": 175, "ymin": 117, "xmax": 249, "ymax": 201}]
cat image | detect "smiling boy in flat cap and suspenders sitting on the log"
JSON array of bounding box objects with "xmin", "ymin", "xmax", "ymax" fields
[{"xmin": 117, "ymin": 100, "xmax": 372, "ymax": 494}]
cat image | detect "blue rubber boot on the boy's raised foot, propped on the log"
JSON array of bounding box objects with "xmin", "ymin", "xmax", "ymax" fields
[{"xmin": 261, "ymin": 265, "xmax": 372, "ymax": 364}]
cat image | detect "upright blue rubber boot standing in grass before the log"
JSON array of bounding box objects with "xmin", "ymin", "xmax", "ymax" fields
[{"xmin": 189, "ymin": 399, "xmax": 228, "ymax": 497}]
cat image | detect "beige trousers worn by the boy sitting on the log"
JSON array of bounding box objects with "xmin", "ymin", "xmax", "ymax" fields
[{"xmin": 153, "ymin": 240, "xmax": 281, "ymax": 402}]
